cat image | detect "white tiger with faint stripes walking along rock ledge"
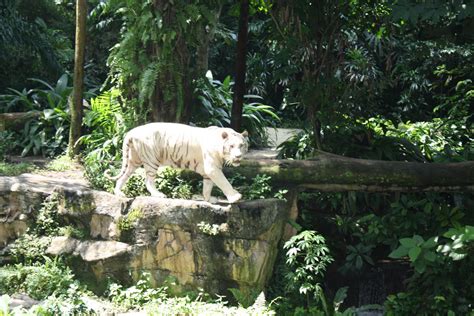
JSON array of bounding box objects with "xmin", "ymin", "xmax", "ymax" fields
[{"xmin": 105, "ymin": 123, "xmax": 248, "ymax": 203}]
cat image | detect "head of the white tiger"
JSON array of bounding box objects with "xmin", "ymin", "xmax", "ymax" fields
[{"xmin": 222, "ymin": 129, "xmax": 249, "ymax": 167}]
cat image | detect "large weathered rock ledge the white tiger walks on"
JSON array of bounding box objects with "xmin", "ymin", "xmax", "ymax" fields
[{"xmin": 0, "ymin": 176, "xmax": 288, "ymax": 294}]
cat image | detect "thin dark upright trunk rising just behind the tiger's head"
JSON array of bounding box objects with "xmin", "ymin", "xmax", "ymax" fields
[{"xmin": 230, "ymin": 0, "xmax": 249, "ymax": 132}]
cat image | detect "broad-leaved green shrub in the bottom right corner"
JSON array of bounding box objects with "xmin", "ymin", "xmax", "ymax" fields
[{"xmin": 385, "ymin": 225, "xmax": 474, "ymax": 315}]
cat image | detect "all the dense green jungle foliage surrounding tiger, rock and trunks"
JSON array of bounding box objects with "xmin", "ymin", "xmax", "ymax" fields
[{"xmin": 0, "ymin": 0, "xmax": 474, "ymax": 315}]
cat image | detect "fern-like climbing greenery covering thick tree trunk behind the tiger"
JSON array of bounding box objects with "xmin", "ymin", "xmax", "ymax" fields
[{"xmin": 107, "ymin": 0, "xmax": 222, "ymax": 122}]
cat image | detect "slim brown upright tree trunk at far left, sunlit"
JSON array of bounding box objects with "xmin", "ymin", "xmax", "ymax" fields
[{"xmin": 68, "ymin": 0, "xmax": 87, "ymax": 157}]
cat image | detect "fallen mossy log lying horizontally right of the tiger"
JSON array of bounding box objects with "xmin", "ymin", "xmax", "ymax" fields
[{"xmin": 225, "ymin": 154, "xmax": 474, "ymax": 192}]
